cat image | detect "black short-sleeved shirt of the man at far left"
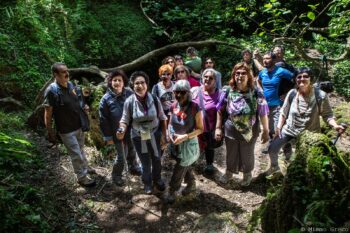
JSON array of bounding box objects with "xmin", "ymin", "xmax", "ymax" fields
[{"xmin": 44, "ymin": 83, "xmax": 81, "ymax": 134}]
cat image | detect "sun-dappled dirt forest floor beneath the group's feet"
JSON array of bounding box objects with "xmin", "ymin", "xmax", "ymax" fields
[{"xmin": 29, "ymin": 95, "xmax": 350, "ymax": 233}]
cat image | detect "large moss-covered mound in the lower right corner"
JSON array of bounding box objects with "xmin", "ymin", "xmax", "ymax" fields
[{"xmin": 255, "ymin": 131, "xmax": 350, "ymax": 233}]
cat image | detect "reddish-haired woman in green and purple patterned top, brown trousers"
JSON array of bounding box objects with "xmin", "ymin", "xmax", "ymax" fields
[{"xmin": 215, "ymin": 62, "xmax": 269, "ymax": 186}]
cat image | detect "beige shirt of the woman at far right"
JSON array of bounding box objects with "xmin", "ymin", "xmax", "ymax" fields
[{"xmin": 280, "ymin": 88, "xmax": 334, "ymax": 137}]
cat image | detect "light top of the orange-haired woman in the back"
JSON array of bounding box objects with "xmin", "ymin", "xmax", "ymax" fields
[{"xmin": 152, "ymin": 82, "xmax": 175, "ymax": 113}]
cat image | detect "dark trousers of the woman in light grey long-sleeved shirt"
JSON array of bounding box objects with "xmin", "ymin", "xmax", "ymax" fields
[{"xmin": 132, "ymin": 129, "xmax": 162, "ymax": 186}]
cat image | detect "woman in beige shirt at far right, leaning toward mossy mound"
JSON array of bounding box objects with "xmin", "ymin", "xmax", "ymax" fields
[{"xmin": 266, "ymin": 67, "xmax": 345, "ymax": 175}]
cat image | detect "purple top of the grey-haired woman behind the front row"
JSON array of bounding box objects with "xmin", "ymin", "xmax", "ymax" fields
[{"xmin": 192, "ymin": 87, "xmax": 220, "ymax": 132}]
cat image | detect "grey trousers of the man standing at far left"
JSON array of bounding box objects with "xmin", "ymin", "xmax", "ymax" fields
[{"xmin": 59, "ymin": 129, "xmax": 88, "ymax": 179}]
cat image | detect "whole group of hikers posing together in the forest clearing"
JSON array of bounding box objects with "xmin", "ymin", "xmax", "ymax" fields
[{"xmin": 45, "ymin": 46, "xmax": 344, "ymax": 203}]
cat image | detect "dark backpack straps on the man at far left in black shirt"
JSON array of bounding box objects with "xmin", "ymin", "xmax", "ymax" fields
[{"xmin": 49, "ymin": 82, "xmax": 90, "ymax": 132}]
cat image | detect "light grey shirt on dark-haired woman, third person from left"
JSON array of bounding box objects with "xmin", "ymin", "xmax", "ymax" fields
[{"xmin": 120, "ymin": 93, "xmax": 167, "ymax": 138}]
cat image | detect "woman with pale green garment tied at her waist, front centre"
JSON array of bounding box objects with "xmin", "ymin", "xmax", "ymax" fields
[{"xmin": 167, "ymin": 80, "xmax": 203, "ymax": 203}]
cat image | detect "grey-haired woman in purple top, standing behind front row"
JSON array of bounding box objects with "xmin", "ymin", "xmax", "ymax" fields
[{"xmin": 191, "ymin": 68, "xmax": 221, "ymax": 175}]
